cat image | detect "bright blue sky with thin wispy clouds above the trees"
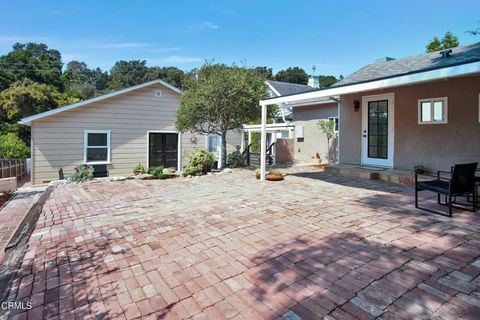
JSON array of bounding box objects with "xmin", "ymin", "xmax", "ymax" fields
[{"xmin": 0, "ymin": 0, "xmax": 480, "ymax": 76}]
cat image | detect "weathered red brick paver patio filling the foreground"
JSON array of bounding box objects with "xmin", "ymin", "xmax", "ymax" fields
[{"xmin": 3, "ymin": 171, "xmax": 480, "ymax": 319}]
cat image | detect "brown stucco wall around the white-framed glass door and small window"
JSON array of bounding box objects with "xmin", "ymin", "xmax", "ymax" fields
[{"xmin": 340, "ymin": 76, "xmax": 480, "ymax": 171}]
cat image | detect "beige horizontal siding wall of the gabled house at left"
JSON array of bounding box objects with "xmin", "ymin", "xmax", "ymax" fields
[{"xmin": 32, "ymin": 84, "xmax": 240, "ymax": 184}]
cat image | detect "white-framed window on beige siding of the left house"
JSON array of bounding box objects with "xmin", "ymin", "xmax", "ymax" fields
[{"xmin": 83, "ymin": 130, "xmax": 110, "ymax": 164}]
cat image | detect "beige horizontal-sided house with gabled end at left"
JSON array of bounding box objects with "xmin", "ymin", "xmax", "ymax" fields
[{"xmin": 20, "ymin": 80, "xmax": 241, "ymax": 184}]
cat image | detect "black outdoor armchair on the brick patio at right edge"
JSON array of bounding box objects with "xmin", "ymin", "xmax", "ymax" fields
[{"xmin": 415, "ymin": 162, "xmax": 478, "ymax": 217}]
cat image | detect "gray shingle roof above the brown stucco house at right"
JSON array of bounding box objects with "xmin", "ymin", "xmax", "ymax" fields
[{"xmin": 333, "ymin": 42, "xmax": 480, "ymax": 86}]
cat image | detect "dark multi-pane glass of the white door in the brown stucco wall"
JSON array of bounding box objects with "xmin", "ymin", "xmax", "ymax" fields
[{"xmin": 368, "ymin": 100, "xmax": 388, "ymax": 159}]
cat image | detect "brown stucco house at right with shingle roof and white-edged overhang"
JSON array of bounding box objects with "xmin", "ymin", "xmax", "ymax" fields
[{"xmin": 260, "ymin": 43, "xmax": 480, "ymax": 178}]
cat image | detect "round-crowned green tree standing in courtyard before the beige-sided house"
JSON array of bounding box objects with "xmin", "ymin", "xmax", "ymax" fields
[{"xmin": 175, "ymin": 63, "xmax": 275, "ymax": 166}]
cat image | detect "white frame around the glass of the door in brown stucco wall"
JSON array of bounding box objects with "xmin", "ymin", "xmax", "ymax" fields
[{"xmin": 361, "ymin": 93, "xmax": 395, "ymax": 168}]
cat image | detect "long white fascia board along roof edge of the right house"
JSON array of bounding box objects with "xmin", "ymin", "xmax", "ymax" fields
[{"xmin": 259, "ymin": 62, "xmax": 480, "ymax": 105}]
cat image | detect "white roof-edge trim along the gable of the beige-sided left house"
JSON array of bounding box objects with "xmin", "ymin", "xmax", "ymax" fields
[{"xmin": 18, "ymin": 80, "xmax": 183, "ymax": 126}]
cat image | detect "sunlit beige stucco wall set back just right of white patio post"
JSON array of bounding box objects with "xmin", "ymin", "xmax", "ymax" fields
[{"xmin": 293, "ymin": 103, "xmax": 341, "ymax": 163}]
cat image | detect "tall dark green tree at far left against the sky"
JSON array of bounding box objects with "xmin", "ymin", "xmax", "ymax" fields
[{"xmin": 0, "ymin": 43, "xmax": 63, "ymax": 90}]
